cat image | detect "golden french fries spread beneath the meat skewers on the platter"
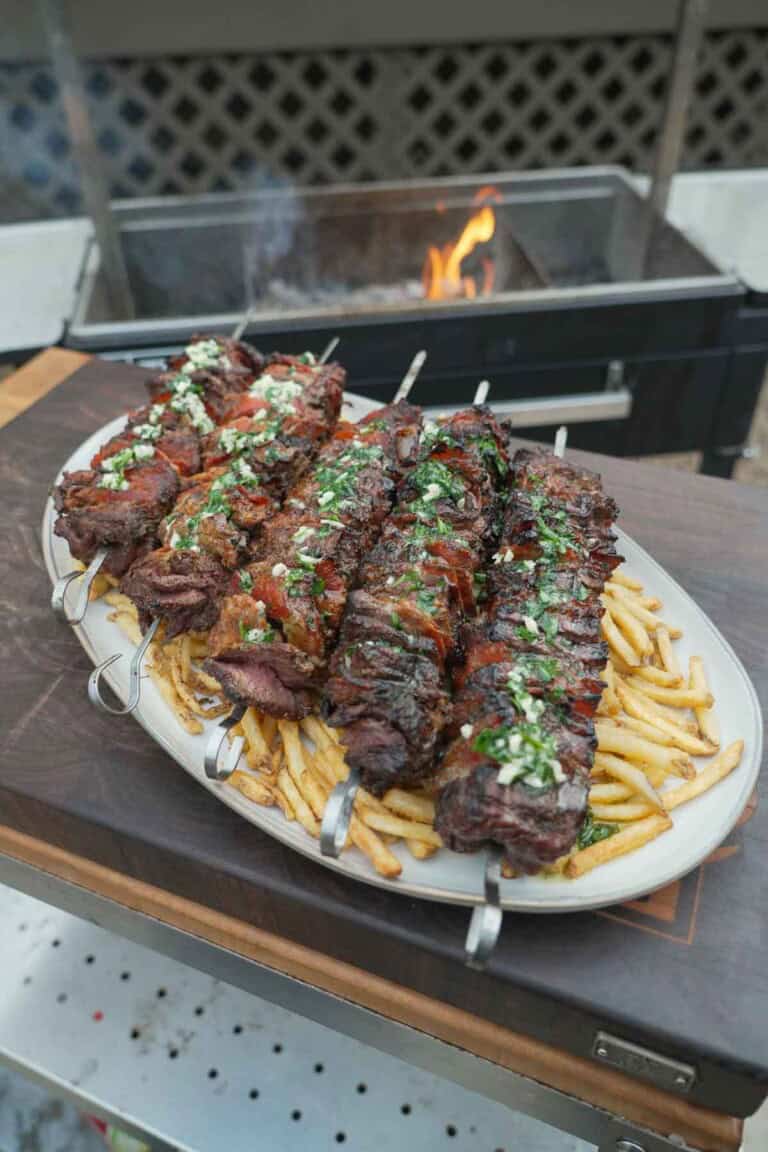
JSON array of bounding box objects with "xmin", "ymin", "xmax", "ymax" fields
[{"xmin": 91, "ymin": 570, "xmax": 744, "ymax": 879}]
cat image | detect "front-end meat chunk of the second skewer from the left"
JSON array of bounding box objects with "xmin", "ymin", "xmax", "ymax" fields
[{"xmin": 120, "ymin": 548, "xmax": 231, "ymax": 639}]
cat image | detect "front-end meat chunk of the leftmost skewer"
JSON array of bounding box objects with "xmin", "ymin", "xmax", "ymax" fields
[{"xmin": 53, "ymin": 446, "xmax": 178, "ymax": 576}]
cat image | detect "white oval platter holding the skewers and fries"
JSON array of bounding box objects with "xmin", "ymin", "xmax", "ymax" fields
[{"xmin": 43, "ymin": 394, "xmax": 762, "ymax": 912}]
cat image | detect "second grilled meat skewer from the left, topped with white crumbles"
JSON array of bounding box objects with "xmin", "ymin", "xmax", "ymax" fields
[{"xmin": 121, "ymin": 356, "xmax": 345, "ymax": 637}]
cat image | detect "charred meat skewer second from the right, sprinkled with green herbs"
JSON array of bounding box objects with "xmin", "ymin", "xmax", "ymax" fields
[{"xmin": 325, "ymin": 408, "xmax": 508, "ymax": 795}]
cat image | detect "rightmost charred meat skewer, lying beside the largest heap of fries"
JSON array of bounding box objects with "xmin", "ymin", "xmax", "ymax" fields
[{"xmin": 435, "ymin": 449, "xmax": 621, "ymax": 873}]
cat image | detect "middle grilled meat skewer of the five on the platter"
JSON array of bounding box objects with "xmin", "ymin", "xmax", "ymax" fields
[{"xmin": 206, "ymin": 403, "xmax": 420, "ymax": 719}]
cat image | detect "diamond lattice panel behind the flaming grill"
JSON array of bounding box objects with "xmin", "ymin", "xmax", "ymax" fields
[{"xmin": 0, "ymin": 30, "xmax": 768, "ymax": 219}]
